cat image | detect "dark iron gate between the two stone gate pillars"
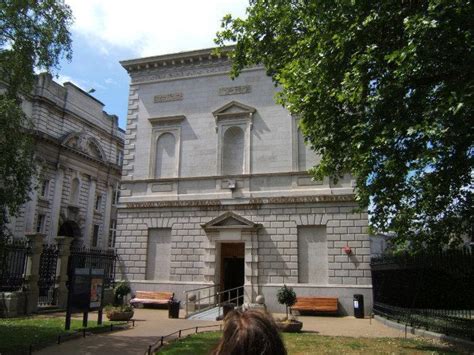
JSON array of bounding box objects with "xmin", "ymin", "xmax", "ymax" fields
[{"xmin": 38, "ymin": 244, "xmax": 59, "ymax": 306}]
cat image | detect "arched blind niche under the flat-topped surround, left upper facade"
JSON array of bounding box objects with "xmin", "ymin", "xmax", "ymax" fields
[{"xmin": 155, "ymin": 133, "xmax": 176, "ymax": 179}]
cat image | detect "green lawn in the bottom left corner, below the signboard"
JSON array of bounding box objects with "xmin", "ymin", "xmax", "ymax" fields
[{"xmin": 0, "ymin": 316, "xmax": 124, "ymax": 355}]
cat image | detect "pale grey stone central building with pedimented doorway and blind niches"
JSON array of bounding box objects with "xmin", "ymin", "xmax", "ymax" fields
[{"xmin": 116, "ymin": 49, "xmax": 372, "ymax": 314}]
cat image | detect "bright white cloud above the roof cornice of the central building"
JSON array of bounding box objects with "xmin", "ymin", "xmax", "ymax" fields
[{"xmin": 66, "ymin": 0, "xmax": 248, "ymax": 56}]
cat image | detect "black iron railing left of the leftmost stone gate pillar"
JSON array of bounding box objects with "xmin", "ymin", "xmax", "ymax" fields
[{"xmin": 0, "ymin": 239, "xmax": 31, "ymax": 292}]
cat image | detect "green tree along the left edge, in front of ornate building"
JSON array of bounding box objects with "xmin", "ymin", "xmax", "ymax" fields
[{"xmin": 0, "ymin": 0, "xmax": 72, "ymax": 235}]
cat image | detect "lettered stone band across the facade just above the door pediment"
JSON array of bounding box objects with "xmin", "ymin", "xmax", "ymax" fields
[{"xmin": 125, "ymin": 195, "xmax": 355, "ymax": 210}]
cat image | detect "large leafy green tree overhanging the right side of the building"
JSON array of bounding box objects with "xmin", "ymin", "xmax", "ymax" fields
[{"xmin": 216, "ymin": 0, "xmax": 474, "ymax": 249}]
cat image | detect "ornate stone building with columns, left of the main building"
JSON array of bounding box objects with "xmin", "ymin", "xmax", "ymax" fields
[{"xmin": 9, "ymin": 73, "xmax": 124, "ymax": 248}]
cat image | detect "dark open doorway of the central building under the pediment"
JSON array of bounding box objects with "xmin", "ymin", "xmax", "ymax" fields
[{"xmin": 221, "ymin": 243, "xmax": 245, "ymax": 305}]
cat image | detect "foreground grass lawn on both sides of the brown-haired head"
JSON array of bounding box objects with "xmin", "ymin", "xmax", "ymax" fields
[{"xmin": 159, "ymin": 332, "xmax": 468, "ymax": 355}]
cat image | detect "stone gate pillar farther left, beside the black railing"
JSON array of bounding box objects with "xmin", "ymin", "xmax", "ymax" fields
[{"xmin": 25, "ymin": 233, "xmax": 45, "ymax": 314}]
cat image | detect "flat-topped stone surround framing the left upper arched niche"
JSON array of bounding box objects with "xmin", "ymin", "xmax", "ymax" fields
[{"xmin": 148, "ymin": 115, "xmax": 186, "ymax": 179}]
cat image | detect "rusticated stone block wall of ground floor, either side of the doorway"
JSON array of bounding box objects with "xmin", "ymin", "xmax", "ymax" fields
[{"xmin": 116, "ymin": 203, "xmax": 371, "ymax": 285}]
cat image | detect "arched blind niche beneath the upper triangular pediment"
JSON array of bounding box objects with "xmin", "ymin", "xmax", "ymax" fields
[{"xmin": 222, "ymin": 126, "xmax": 244, "ymax": 175}]
